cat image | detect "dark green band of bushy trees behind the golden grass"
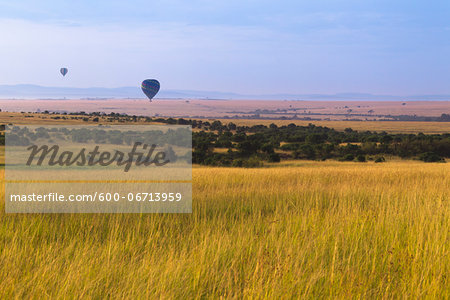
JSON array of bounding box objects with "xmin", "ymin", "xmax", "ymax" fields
[{"xmin": 1, "ymin": 113, "xmax": 450, "ymax": 167}]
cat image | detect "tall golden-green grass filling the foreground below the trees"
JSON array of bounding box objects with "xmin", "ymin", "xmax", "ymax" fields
[{"xmin": 0, "ymin": 162, "xmax": 450, "ymax": 298}]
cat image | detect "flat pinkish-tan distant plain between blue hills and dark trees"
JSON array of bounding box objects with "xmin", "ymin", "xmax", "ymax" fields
[{"xmin": 0, "ymin": 99, "xmax": 450, "ymax": 121}]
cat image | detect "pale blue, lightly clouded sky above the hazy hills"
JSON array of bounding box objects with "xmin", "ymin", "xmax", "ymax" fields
[{"xmin": 0, "ymin": 0, "xmax": 450, "ymax": 96}]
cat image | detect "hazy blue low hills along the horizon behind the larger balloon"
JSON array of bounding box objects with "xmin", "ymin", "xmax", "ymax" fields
[{"xmin": 0, "ymin": 84, "xmax": 450, "ymax": 101}]
